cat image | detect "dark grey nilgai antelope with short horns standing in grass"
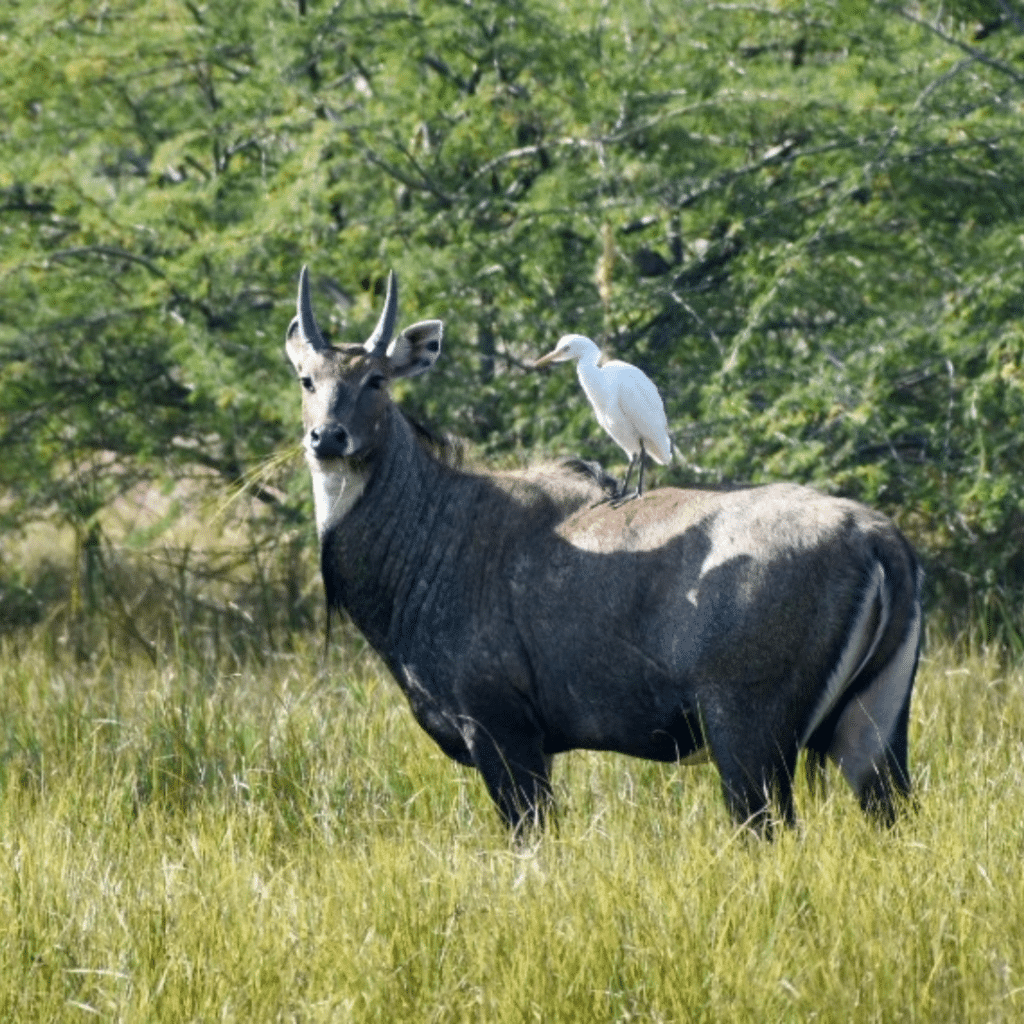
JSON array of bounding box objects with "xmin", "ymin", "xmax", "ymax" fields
[{"xmin": 287, "ymin": 268, "xmax": 922, "ymax": 833}]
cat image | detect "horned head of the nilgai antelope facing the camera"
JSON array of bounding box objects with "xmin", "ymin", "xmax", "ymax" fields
[{"xmin": 286, "ymin": 267, "xmax": 443, "ymax": 472}]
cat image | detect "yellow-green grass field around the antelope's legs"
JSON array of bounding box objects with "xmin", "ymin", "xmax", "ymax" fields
[{"xmin": 0, "ymin": 618, "xmax": 1024, "ymax": 1024}]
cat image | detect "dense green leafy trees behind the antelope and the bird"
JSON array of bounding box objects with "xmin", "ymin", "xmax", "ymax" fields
[{"xmin": 0, "ymin": 0, "xmax": 1024, "ymax": 628}]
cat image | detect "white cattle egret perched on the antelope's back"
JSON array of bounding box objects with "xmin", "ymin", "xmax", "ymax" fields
[{"xmin": 534, "ymin": 334, "xmax": 672, "ymax": 498}]
